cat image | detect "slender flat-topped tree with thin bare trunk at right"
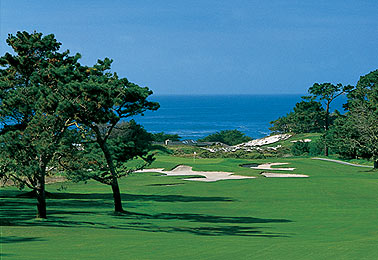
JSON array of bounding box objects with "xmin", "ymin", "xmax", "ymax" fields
[{"xmin": 308, "ymin": 83, "xmax": 353, "ymax": 156}]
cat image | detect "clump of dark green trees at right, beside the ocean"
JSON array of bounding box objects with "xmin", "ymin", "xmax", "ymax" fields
[{"xmin": 270, "ymin": 70, "xmax": 378, "ymax": 168}]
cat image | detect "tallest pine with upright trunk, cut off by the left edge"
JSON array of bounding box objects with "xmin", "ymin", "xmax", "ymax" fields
[{"xmin": 0, "ymin": 32, "xmax": 80, "ymax": 218}]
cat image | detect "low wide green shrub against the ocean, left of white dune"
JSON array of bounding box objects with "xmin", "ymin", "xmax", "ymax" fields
[{"xmin": 199, "ymin": 129, "xmax": 252, "ymax": 145}]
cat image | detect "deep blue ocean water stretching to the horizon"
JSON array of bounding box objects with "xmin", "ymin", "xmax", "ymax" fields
[{"xmin": 134, "ymin": 95, "xmax": 345, "ymax": 140}]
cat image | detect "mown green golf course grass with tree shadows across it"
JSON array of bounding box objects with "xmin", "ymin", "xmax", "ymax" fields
[{"xmin": 0, "ymin": 156, "xmax": 378, "ymax": 259}]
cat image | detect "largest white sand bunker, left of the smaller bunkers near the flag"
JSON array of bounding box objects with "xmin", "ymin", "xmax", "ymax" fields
[{"xmin": 136, "ymin": 165, "xmax": 256, "ymax": 182}]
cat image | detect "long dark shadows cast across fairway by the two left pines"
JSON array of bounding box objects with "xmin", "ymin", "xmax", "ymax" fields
[{"xmin": 0, "ymin": 192, "xmax": 292, "ymax": 237}]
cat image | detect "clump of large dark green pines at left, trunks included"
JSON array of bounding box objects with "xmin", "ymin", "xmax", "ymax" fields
[{"xmin": 0, "ymin": 32, "xmax": 159, "ymax": 218}]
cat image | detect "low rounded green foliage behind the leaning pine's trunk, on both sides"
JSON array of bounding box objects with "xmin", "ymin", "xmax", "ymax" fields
[{"xmin": 57, "ymin": 120, "xmax": 156, "ymax": 184}]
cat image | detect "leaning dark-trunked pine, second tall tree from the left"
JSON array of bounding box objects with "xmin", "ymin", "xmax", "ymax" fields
[{"xmin": 58, "ymin": 58, "xmax": 159, "ymax": 212}]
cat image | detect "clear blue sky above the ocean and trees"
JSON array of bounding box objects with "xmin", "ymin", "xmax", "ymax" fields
[{"xmin": 0, "ymin": 0, "xmax": 378, "ymax": 95}]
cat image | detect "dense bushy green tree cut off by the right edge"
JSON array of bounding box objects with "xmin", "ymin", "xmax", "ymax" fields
[{"xmin": 328, "ymin": 70, "xmax": 378, "ymax": 167}]
